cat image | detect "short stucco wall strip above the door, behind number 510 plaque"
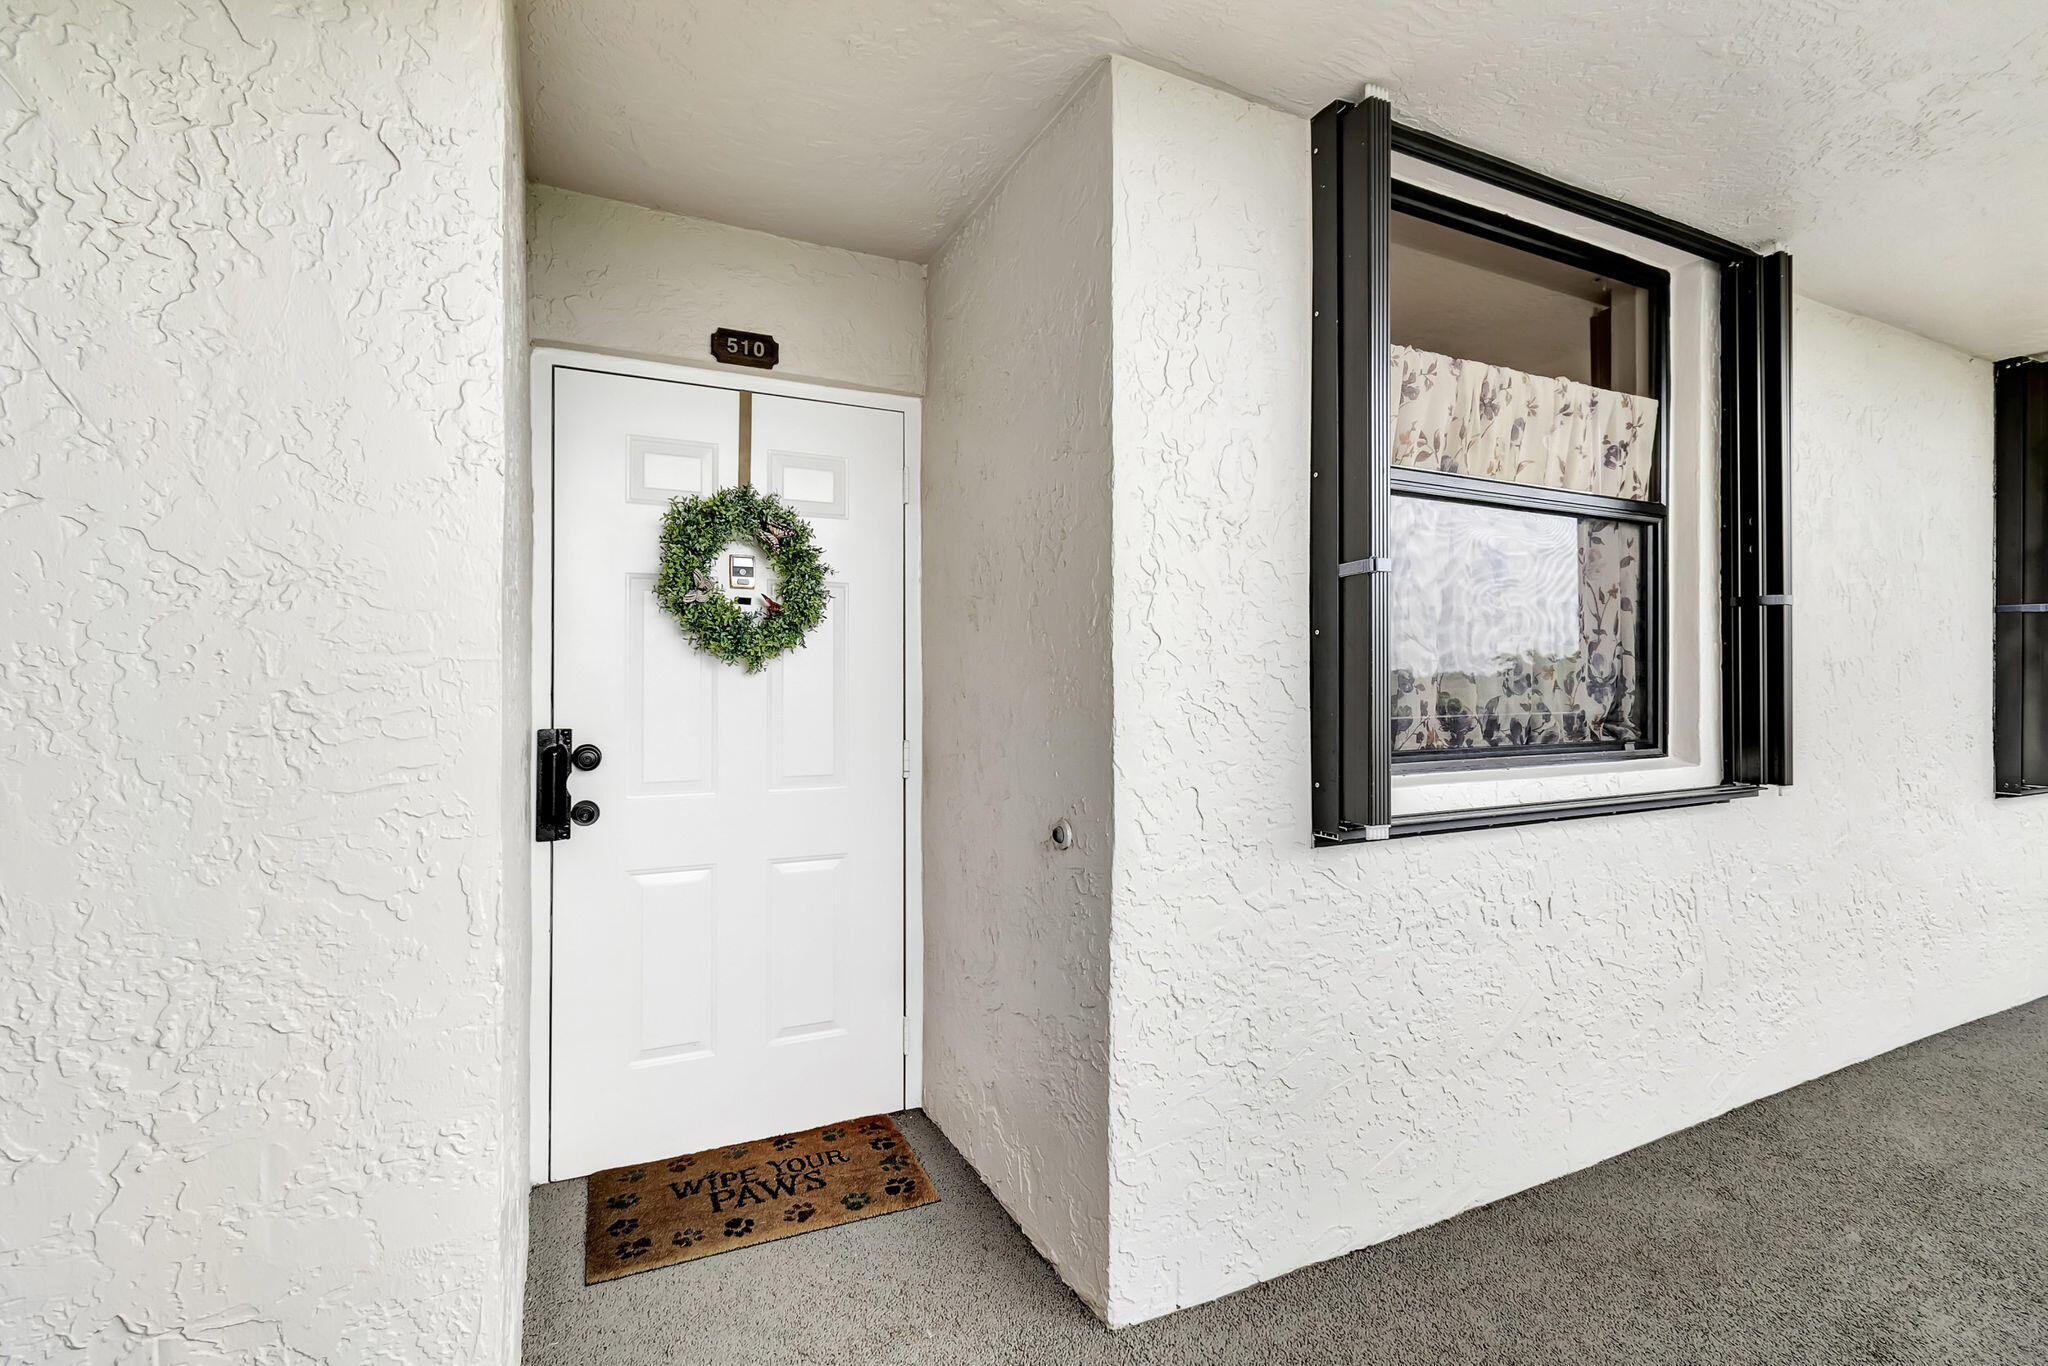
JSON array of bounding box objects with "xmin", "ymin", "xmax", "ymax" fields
[{"xmin": 526, "ymin": 184, "xmax": 926, "ymax": 393}]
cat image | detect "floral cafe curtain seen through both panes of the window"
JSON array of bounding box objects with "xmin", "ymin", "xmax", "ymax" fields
[{"xmin": 1393, "ymin": 346, "xmax": 1657, "ymax": 752}]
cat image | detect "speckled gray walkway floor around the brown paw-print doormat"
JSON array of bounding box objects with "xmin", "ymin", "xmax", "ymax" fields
[{"xmin": 526, "ymin": 999, "xmax": 2048, "ymax": 1366}]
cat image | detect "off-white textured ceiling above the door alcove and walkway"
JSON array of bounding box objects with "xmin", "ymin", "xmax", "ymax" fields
[{"xmin": 524, "ymin": 0, "xmax": 2048, "ymax": 356}]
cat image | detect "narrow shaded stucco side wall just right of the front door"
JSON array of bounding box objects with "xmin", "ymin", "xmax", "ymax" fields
[{"xmin": 924, "ymin": 69, "xmax": 1110, "ymax": 1307}]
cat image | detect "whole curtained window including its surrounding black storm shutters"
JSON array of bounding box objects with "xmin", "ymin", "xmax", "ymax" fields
[{"xmin": 1311, "ymin": 98, "xmax": 1790, "ymax": 844}]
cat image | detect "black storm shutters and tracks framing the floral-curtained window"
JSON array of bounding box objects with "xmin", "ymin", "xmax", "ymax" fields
[{"xmin": 1309, "ymin": 98, "xmax": 1792, "ymax": 846}]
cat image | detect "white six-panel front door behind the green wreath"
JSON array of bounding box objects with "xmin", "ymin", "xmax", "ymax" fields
[{"xmin": 535, "ymin": 365, "xmax": 905, "ymax": 1180}]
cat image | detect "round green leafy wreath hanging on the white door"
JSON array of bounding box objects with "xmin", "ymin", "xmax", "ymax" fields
[{"xmin": 653, "ymin": 483, "xmax": 831, "ymax": 674}]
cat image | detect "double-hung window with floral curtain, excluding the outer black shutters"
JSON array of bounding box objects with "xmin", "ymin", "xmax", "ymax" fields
[{"xmin": 1389, "ymin": 192, "xmax": 1669, "ymax": 768}]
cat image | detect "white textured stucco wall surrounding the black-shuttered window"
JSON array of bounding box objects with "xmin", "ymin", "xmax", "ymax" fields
[{"xmin": 1110, "ymin": 61, "xmax": 2048, "ymax": 1323}]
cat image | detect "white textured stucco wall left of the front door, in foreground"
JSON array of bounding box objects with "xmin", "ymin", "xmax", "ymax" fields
[{"xmin": 0, "ymin": 0, "xmax": 526, "ymax": 1366}]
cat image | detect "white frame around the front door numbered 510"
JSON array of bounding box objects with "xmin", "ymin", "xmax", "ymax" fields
[{"xmin": 520, "ymin": 346, "xmax": 924, "ymax": 1186}]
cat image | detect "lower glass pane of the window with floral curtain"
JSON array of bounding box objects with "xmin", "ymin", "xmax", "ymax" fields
[{"xmin": 1391, "ymin": 498, "xmax": 1645, "ymax": 754}]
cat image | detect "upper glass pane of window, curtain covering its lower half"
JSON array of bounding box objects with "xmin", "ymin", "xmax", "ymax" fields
[{"xmin": 1391, "ymin": 213, "xmax": 1657, "ymax": 498}]
